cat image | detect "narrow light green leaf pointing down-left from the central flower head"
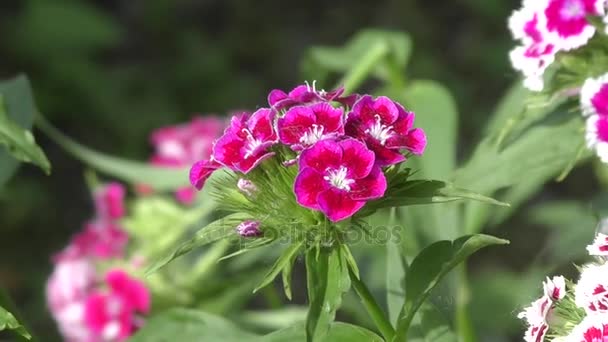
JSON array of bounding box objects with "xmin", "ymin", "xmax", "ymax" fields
[{"xmin": 146, "ymin": 213, "xmax": 249, "ymax": 275}]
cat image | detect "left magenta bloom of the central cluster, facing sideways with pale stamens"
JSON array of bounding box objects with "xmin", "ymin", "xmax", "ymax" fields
[{"xmin": 213, "ymin": 108, "xmax": 278, "ymax": 173}]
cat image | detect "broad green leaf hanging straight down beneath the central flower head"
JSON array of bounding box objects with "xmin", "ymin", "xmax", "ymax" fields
[{"xmin": 305, "ymin": 247, "xmax": 350, "ymax": 342}]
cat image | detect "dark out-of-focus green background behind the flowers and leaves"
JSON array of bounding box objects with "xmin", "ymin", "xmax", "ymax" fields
[{"xmin": 0, "ymin": 0, "xmax": 597, "ymax": 341}]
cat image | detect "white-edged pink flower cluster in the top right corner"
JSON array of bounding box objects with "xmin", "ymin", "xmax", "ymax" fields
[{"xmin": 509, "ymin": 0, "xmax": 605, "ymax": 91}]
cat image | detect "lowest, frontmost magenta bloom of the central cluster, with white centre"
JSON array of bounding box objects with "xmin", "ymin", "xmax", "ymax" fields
[{"xmin": 294, "ymin": 139, "xmax": 386, "ymax": 222}]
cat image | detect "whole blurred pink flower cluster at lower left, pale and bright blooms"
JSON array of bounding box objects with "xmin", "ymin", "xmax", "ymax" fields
[{"xmin": 46, "ymin": 183, "xmax": 150, "ymax": 342}]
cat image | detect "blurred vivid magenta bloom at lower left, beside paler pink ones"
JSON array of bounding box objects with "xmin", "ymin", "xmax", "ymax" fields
[{"xmin": 84, "ymin": 270, "xmax": 150, "ymax": 341}]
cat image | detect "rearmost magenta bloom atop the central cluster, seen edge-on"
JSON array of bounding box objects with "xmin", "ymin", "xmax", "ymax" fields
[{"xmin": 268, "ymin": 82, "xmax": 357, "ymax": 110}]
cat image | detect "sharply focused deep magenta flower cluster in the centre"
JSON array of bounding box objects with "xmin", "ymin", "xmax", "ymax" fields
[{"xmin": 190, "ymin": 84, "xmax": 426, "ymax": 222}]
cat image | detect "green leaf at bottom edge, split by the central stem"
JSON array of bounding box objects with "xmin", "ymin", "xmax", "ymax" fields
[{"xmin": 255, "ymin": 322, "xmax": 384, "ymax": 342}]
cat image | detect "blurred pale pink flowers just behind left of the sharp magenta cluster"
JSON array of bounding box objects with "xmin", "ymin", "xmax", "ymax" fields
[{"xmin": 150, "ymin": 117, "xmax": 225, "ymax": 204}]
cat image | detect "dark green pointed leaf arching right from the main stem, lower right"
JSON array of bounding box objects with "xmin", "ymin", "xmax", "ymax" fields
[{"xmin": 395, "ymin": 234, "xmax": 509, "ymax": 341}]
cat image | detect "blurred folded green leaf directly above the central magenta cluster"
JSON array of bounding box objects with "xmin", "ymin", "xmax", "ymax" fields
[{"xmin": 302, "ymin": 29, "xmax": 412, "ymax": 85}]
